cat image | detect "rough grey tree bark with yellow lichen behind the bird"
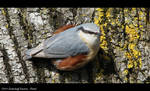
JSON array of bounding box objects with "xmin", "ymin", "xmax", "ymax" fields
[{"xmin": 0, "ymin": 8, "xmax": 150, "ymax": 83}]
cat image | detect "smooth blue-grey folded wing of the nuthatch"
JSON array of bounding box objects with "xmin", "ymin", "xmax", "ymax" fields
[{"xmin": 44, "ymin": 30, "xmax": 89, "ymax": 58}]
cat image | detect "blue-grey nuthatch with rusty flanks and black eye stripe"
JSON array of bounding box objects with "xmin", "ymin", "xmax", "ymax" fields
[{"xmin": 24, "ymin": 23, "xmax": 100, "ymax": 71}]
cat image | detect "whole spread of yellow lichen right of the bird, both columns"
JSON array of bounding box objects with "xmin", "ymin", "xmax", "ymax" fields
[{"xmin": 94, "ymin": 8, "xmax": 143, "ymax": 81}]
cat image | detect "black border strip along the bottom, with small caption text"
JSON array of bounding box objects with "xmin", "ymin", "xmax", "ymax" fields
[{"xmin": 0, "ymin": 83, "xmax": 150, "ymax": 91}]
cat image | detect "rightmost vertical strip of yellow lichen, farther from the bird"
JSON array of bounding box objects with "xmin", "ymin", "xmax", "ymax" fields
[{"xmin": 125, "ymin": 8, "xmax": 145, "ymax": 69}]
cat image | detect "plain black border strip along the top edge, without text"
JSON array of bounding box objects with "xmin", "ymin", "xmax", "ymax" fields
[{"xmin": 0, "ymin": 0, "xmax": 150, "ymax": 7}]
